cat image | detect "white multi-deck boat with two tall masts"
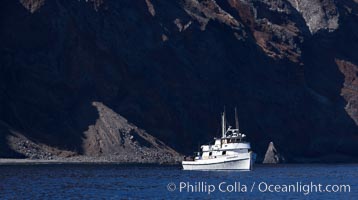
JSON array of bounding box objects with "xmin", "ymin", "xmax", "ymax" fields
[{"xmin": 182, "ymin": 109, "xmax": 256, "ymax": 170}]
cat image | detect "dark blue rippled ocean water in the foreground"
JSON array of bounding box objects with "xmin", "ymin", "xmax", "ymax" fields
[{"xmin": 0, "ymin": 165, "xmax": 358, "ymax": 200}]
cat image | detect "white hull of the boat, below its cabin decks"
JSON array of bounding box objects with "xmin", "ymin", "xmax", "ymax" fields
[{"xmin": 182, "ymin": 152, "xmax": 255, "ymax": 170}]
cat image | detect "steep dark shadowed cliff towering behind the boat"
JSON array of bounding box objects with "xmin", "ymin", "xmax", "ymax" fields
[{"xmin": 0, "ymin": 0, "xmax": 358, "ymax": 161}]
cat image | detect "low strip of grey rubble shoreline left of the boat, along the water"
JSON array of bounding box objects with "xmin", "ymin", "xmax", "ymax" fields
[{"xmin": 6, "ymin": 136, "xmax": 183, "ymax": 165}]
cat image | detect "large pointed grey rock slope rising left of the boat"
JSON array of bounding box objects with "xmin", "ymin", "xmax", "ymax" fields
[{"xmin": 83, "ymin": 102, "xmax": 181, "ymax": 163}]
